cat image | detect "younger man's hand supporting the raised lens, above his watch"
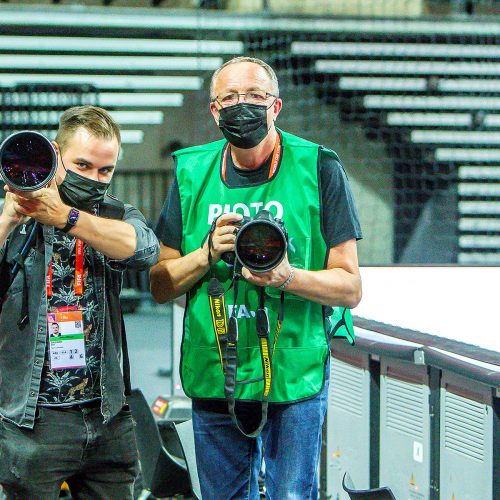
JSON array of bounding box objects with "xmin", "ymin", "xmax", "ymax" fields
[{"xmin": 6, "ymin": 180, "xmax": 70, "ymax": 228}]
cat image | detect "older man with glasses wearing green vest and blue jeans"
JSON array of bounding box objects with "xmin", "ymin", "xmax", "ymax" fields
[{"xmin": 151, "ymin": 57, "xmax": 361, "ymax": 500}]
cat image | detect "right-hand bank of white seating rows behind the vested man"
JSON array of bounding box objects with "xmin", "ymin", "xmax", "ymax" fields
[{"xmin": 291, "ymin": 30, "xmax": 500, "ymax": 264}]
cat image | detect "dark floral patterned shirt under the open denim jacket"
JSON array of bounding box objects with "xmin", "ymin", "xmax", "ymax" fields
[{"xmin": 38, "ymin": 229, "xmax": 103, "ymax": 406}]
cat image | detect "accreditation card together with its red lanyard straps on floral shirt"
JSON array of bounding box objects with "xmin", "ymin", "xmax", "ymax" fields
[{"xmin": 46, "ymin": 239, "xmax": 87, "ymax": 370}]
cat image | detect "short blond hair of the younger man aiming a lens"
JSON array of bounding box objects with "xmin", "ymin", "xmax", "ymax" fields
[{"xmin": 56, "ymin": 106, "xmax": 121, "ymax": 148}]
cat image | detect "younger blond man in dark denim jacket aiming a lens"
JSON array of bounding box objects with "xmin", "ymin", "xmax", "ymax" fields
[{"xmin": 0, "ymin": 106, "xmax": 158, "ymax": 500}]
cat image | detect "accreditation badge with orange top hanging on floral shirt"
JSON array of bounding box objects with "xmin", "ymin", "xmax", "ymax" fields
[{"xmin": 47, "ymin": 311, "xmax": 87, "ymax": 370}]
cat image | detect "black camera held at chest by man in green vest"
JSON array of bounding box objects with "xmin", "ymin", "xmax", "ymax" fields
[{"xmin": 222, "ymin": 210, "xmax": 288, "ymax": 273}]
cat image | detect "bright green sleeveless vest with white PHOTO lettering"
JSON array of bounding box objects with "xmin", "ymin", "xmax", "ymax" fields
[{"xmin": 175, "ymin": 132, "xmax": 352, "ymax": 402}]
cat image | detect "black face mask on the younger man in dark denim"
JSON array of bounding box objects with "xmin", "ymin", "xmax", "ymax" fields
[{"xmin": 59, "ymin": 170, "xmax": 109, "ymax": 212}]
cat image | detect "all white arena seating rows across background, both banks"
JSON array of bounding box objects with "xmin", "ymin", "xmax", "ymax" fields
[{"xmin": 0, "ymin": 6, "xmax": 500, "ymax": 263}]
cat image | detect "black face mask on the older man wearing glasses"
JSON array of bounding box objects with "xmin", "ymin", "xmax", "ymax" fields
[{"xmin": 219, "ymin": 102, "xmax": 272, "ymax": 149}]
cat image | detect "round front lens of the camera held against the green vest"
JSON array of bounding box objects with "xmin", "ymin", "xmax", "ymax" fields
[{"xmin": 235, "ymin": 220, "xmax": 287, "ymax": 272}]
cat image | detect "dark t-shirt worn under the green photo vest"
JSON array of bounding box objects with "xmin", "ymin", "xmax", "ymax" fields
[{"xmin": 156, "ymin": 138, "xmax": 362, "ymax": 414}]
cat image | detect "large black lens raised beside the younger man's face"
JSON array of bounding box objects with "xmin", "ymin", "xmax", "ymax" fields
[{"xmin": 0, "ymin": 131, "xmax": 57, "ymax": 191}]
